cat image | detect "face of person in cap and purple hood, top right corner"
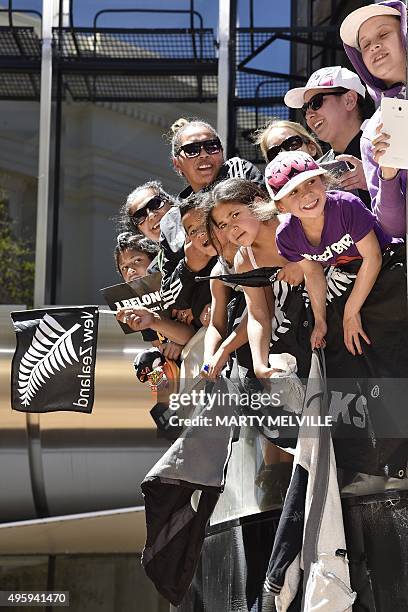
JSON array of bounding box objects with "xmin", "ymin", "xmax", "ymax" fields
[{"xmin": 358, "ymin": 15, "xmax": 406, "ymax": 86}]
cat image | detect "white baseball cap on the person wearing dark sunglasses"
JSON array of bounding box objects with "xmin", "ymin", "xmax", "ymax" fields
[{"xmin": 283, "ymin": 66, "xmax": 366, "ymax": 108}]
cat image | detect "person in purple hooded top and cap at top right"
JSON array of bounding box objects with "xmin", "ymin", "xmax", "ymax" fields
[{"xmin": 340, "ymin": 0, "xmax": 407, "ymax": 237}]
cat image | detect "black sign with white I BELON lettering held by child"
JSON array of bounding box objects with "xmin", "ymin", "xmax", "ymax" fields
[{"xmin": 101, "ymin": 272, "xmax": 163, "ymax": 342}]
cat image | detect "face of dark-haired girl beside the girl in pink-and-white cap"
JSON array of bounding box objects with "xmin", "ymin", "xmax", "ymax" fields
[{"xmin": 212, "ymin": 201, "xmax": 261, "ymax": 246}]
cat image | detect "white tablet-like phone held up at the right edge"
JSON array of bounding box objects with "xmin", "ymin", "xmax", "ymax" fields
[{"xmin": 380, "ymin": 98, "xmax": 408, "ymax": 170}]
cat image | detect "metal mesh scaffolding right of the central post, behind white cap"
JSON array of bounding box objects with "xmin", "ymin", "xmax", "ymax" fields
[{"xmin": 229, "ymin": 0, "xmax": 354, "ymax": 164}]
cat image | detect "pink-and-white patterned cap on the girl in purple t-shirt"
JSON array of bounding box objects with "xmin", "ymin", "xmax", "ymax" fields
[{"xmin": 265, "ymin": 151, "xmax": 327, "ymax": 202}]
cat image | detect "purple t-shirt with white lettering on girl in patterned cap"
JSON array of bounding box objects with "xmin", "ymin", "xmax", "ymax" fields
[{"xmin": 276, "ymin": 191, "xmax": 393, "ymax": 265}]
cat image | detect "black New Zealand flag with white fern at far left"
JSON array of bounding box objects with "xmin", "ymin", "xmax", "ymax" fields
[{"xmin": 11, "ymin": 306, "xmax": 99, "ymax": 413}]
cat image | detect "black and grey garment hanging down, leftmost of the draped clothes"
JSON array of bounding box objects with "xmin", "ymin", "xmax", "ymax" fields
[{"xmin": 141, "ymin": 377, "xmax": 239, "ymax": 606}]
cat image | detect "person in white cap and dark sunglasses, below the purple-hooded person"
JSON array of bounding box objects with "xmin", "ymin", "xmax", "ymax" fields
[{"xmin": 284, "ymin": 66, "xmax": 374, "ymax": 208}]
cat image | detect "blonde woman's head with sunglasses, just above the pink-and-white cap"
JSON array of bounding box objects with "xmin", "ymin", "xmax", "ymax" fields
[{"xmin": 254, "ymin": 119, "xmax": 323, "ymax": 163}]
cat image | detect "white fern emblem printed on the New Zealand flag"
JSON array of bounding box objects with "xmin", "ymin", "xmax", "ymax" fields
[{"xmin": 18, "ymin": 314, "xmax": 81, "ymax": 406}]
